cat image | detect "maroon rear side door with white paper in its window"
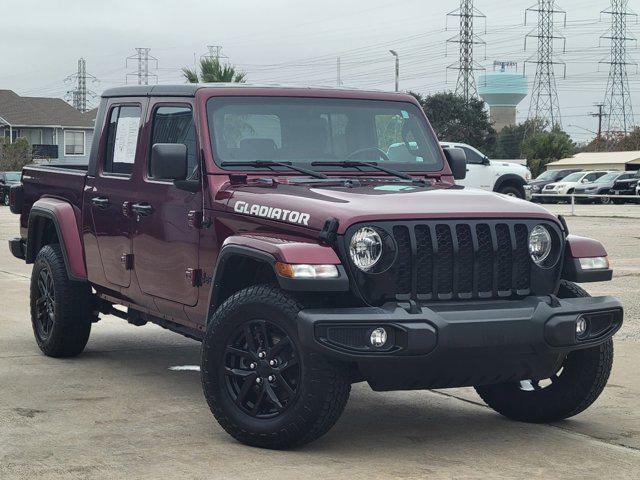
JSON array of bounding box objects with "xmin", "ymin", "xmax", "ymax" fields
[{"xmin": 85, "ymin": 101, "xmax": 144, "ymax": 287}]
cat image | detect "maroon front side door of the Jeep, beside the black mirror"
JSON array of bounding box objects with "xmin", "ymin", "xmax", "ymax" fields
[{"xmin": 131, "ymin": 99, "xmax": 202, "ymax": 305}]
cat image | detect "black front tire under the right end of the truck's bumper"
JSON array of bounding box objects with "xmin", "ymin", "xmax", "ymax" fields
[{"xmin": 476, "ymin": 280, "xmax": 613, "ymax": 423}]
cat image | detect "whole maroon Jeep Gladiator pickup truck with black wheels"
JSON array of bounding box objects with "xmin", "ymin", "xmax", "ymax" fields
[{"xmin": 10, "ymin": 84, "xmax": 623, "ymax": 448}]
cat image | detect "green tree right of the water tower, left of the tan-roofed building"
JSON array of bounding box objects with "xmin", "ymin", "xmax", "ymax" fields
[{"xmin": 521, "ymin": 126, "xmax": 576, "ymax": 177}]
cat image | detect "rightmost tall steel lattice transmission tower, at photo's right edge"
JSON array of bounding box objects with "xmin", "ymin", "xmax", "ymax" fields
[{"xmin": 600, "ymin": 0, "xmax": 637, "ymax": 133}]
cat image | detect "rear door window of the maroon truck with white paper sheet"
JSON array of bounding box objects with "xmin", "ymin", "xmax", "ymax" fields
[{"xmin": 103, "ymin": 105, "xmax": 142, "ymax": 176}]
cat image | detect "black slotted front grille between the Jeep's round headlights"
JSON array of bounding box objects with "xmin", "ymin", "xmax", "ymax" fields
[{"xmin": 345, "ymin": 219, "xmax": 563, "ymax": 303}]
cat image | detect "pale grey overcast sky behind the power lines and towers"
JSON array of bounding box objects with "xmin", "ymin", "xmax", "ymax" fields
[{"xmin": 0, "ymin": 0, "xmax": 640, "ymax": 141}]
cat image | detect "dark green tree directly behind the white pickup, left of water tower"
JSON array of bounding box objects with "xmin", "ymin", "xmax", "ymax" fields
[{"xmin": 409, "ymin": 92, "xmax": 496, "ymax": 156}]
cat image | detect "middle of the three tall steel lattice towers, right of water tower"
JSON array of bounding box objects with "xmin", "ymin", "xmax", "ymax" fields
[{"xmin": 524, "ymin": 0, "xmax": 567, "ymax": 128}]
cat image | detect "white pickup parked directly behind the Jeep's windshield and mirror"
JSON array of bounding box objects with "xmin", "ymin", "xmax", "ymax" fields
[{"xmin": 440, "ymin": 142, "xmax": 531, "ymax": 200}]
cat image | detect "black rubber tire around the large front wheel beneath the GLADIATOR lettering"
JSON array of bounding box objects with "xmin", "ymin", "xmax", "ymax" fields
[{"xmin": 201, "ymin": 285, "xmax": 351, "ymax": 449}]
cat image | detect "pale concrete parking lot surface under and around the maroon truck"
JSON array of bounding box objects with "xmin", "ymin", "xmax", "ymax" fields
[{"xmin": 0, "ymin": 205, "xmax": 640, "ymax": 480}]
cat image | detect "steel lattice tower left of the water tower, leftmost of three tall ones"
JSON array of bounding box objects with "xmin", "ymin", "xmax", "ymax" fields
[{"xmin": 447, "ymin": 0, "xmax": 486, "ymax": 101}]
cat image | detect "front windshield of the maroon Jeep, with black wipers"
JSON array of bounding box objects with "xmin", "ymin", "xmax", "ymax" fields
[{"xmin": 207, "ymin": 97, "xmax": 443, "ymax": 172}]
